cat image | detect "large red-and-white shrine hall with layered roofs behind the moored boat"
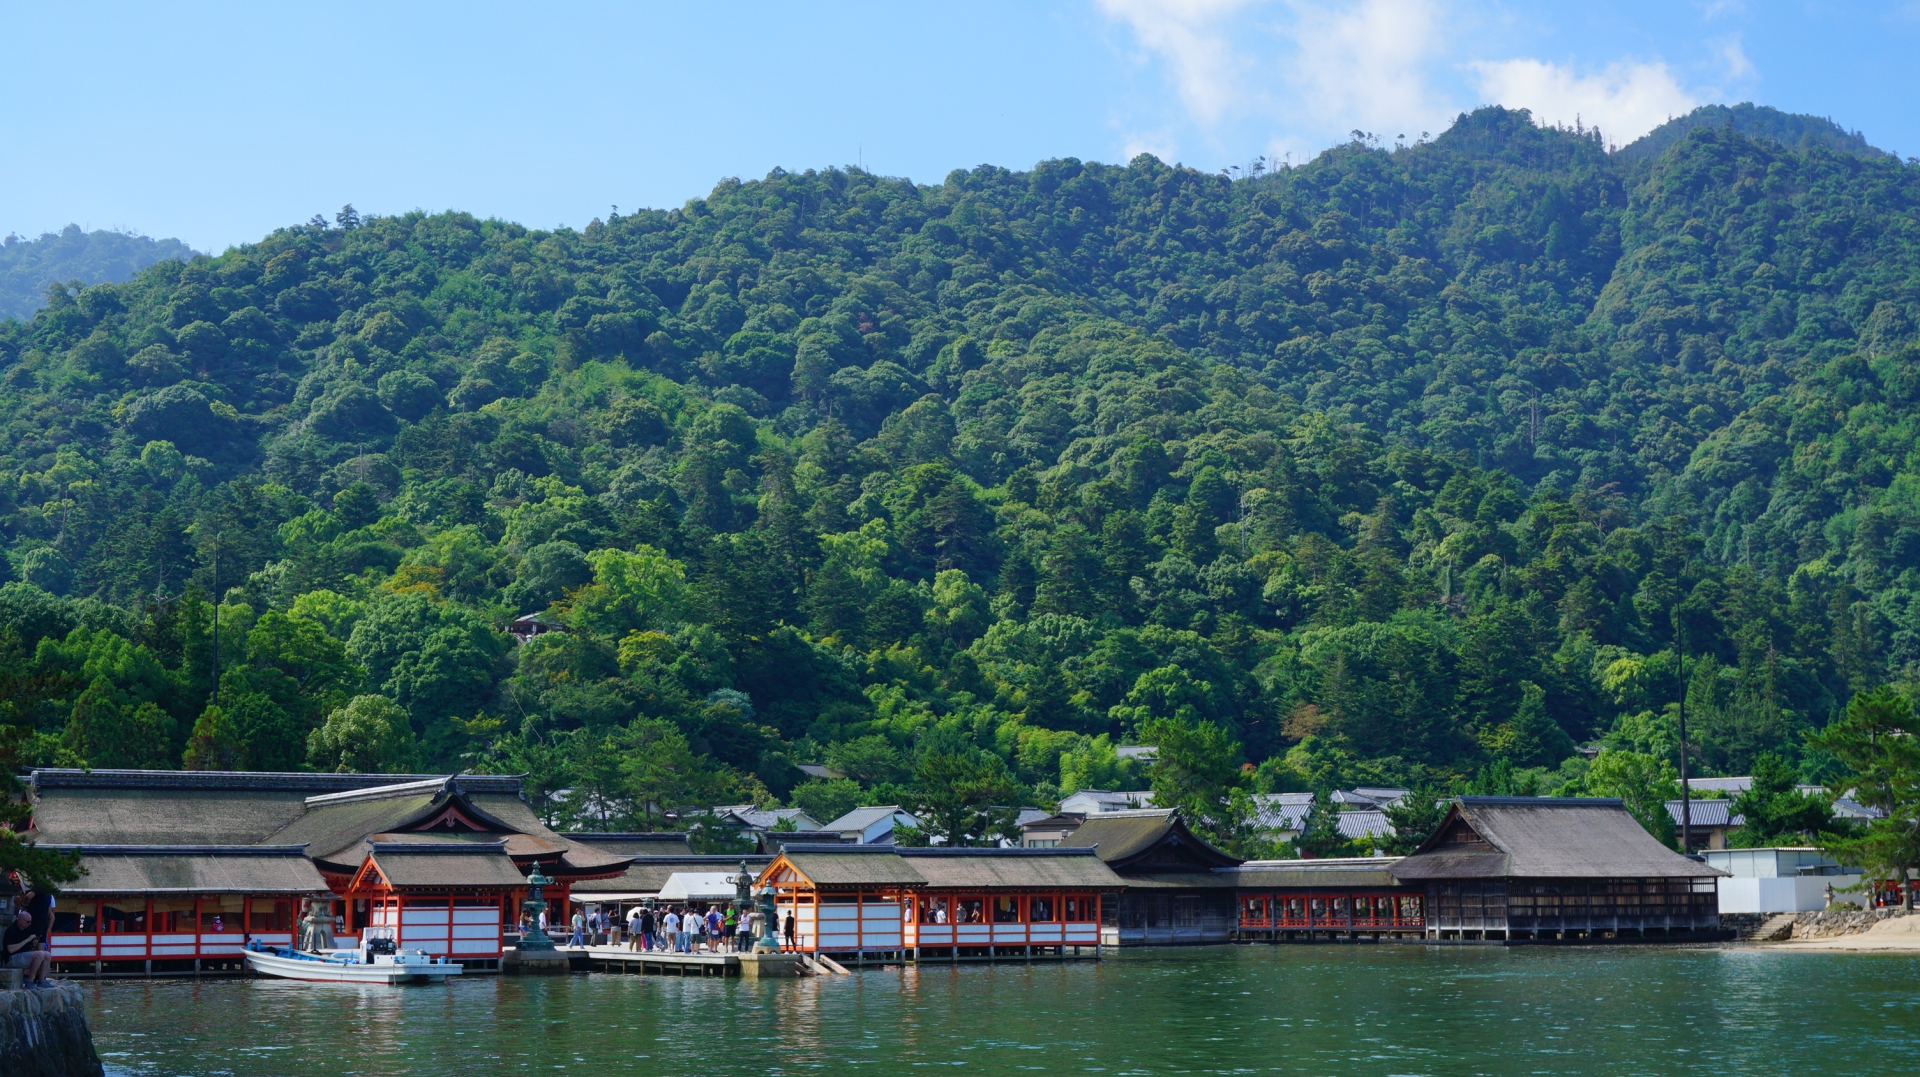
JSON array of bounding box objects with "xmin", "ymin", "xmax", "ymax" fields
[{"xmin": 27, "ymin": 768, "xmax": 632, "ymax": 973}]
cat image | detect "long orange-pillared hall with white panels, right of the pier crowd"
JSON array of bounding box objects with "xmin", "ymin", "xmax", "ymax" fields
[{"xmin": 758, "ymin": 845, "xmax": 1127, "ymax": 962}]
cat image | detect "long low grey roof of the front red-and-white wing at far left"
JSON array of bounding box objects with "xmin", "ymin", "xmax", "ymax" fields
[{"xmin": 40, "ymin": 845, "xmax": 326, "ymax": 897}]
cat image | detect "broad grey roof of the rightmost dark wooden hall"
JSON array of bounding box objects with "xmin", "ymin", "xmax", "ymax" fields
[{"xmin": 1394, "ymin": 797, "xmax": 1724, "ymax": 879}]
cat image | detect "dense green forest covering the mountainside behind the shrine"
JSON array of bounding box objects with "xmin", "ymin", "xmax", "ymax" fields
[{"xmin": 0, "ymin": 108, "xmax": 1920, "ymax": 841}]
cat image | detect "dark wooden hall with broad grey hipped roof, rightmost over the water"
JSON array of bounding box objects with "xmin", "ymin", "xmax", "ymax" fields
[{"xmin": 1392, "ymin": 797, "xmax": 1724, "ymax": 941}]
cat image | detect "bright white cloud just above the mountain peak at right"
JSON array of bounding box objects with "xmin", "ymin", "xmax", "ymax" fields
[{"xmin": 1467, "ymin": 60, "xmax": 1699, "ymax": 146}]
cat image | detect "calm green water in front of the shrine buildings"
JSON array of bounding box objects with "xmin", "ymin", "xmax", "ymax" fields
[{"xmin": 90, "ymin": 946, "xmax": 1920, "ymax": 1077}]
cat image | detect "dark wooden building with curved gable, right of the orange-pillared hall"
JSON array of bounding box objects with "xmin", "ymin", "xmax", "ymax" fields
[{"xmin": 1062, "ymin": 808, "xmax": 1240, "ymax": 946}]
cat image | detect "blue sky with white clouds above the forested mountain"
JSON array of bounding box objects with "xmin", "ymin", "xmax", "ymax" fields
[{"xmin": 0, "ymin": 0, "xmax": 1920, "ymax": 250}]
